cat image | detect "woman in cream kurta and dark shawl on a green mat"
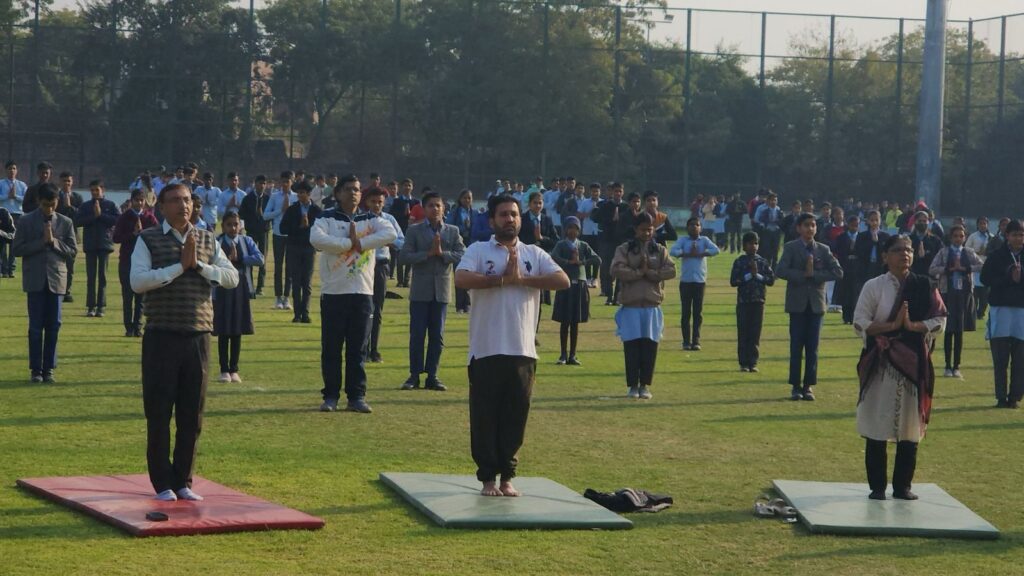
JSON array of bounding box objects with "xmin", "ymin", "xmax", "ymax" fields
[{"xmin": 853, "ymin": 237, "xmax": 945, "ymax": 500}]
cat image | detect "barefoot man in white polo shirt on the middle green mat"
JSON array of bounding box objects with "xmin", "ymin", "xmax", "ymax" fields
[{"xmin": 455, "ymin": 195, "xmax": 569, "ymax": 496}]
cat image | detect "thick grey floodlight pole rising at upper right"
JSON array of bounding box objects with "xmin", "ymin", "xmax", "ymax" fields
[{"xmin": 916, "ymin": 0, "xmax": 949, "ymax": 213}]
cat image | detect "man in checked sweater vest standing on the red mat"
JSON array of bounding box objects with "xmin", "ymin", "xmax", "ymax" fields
[{"xmin": 131, "ymin": 183, "xmax": 239, "ymax": 501}]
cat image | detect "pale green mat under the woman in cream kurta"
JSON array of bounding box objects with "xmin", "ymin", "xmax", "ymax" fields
[{"xmin": 772, "ymin": 480, "xmax": 999, "ymax": 539}]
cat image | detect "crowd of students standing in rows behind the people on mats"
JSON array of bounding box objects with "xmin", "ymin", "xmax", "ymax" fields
[{"xmin": 0, "ymin": 163, "xmax": 1024, "ymax": 405}]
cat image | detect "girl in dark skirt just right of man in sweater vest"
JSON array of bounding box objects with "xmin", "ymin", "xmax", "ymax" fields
[{"xmin": 213, "ymin": 211, "xmax": 263, "ymax": 382}]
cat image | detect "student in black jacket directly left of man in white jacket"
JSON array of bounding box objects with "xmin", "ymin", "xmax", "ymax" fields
[{"xmin": 281, "ymin": 181, "xmax": 322, "ymax": 324}]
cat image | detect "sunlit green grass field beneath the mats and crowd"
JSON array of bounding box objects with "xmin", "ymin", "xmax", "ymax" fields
[{"xmin": 0, "ymin": 255, "xmax": 1024, "ymax": 576}]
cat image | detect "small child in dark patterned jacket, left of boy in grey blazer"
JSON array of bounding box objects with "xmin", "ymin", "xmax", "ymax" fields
[{"xmin": 729, "ymin": 232, "xmax": 775, "ymax": 372}]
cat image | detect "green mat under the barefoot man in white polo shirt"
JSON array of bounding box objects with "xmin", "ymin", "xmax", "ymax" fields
[{"xmin": 380, "ymin": 472, "xmax": 633, "ymax": 530}]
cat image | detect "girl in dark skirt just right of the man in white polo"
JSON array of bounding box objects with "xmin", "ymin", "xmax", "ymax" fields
[{"xmin": 551, "ymin": 216, "xmax": 601, "ymax": 366}]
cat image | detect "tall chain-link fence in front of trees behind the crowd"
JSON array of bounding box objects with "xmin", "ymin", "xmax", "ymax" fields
[{"xmin": 0, "ymin": 0, "xmax": 1024, "ymax": 213}]
